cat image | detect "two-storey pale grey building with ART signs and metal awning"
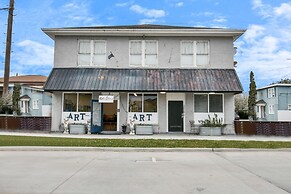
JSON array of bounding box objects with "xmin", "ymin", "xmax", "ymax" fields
[{"xmin": 42, "ymin": 25, "xmax": 244, "ymax": 133}]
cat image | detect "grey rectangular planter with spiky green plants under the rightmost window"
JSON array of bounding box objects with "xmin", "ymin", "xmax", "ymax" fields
[{"xmin": 199, "ymin": 114, "xmax": 225, "ymax": 136}]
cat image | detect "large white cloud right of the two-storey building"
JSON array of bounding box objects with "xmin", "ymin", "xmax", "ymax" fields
[{"xmin": 236, "ymin": 0, "xmax": 291, "ymax": 90}]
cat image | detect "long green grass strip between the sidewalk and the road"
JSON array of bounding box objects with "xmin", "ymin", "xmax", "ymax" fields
[{"xmin": 0, "ymin": 135, "xmax": 291, "ymax": 149}]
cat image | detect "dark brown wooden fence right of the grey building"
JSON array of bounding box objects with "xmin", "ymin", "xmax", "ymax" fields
[{"xmin": 234, "ymin": 121, "xmax": 291, "ymax": 136}]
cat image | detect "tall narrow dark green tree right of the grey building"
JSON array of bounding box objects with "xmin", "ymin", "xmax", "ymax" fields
[{"xmin": 248, "ymin": 71, "xmax": 257, "ymax": 120}]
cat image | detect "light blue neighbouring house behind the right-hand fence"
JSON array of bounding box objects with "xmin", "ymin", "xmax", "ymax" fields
[{"xmin": 256, "ymin": 84, "xmax": 291, "ymax": 121}]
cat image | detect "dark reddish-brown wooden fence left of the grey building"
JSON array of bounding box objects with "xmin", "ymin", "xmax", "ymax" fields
[{"xmin": 0, "ymin": 115, "xmax": 51, "ymax": 131}]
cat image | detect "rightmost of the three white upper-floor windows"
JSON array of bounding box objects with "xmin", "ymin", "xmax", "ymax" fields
[{"xmin": 181, "ymin": 40, "xmax": 209, "ymax": 67}]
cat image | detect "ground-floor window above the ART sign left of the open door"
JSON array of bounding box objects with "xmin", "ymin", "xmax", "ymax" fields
[{"xmin": 63, "ymin": 93, "xmax": 92, "ymax": 112}]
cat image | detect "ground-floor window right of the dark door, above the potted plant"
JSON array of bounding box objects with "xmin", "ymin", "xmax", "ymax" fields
[{"xmin": 194, "ymin": 94, "xmax": 223, "ymax": 113}]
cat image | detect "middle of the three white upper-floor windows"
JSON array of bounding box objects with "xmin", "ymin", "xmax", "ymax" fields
[{"xmin": 129, "ymin": 40, "xmax": 158, "ymax": 67}]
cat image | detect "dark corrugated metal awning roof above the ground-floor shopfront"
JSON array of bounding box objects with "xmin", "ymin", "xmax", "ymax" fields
[{"xmin": 44, "ymin": 68, "xmax": 243, "ymax": 93}]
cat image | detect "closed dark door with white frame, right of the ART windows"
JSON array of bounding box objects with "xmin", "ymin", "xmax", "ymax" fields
[{"xmin": 168, "ymin": 101, "xmax": 184, "ymax": 132}]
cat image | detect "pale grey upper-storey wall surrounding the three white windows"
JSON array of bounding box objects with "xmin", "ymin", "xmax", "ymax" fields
[{"xmin": 55, "ymin": 36, "xmax": 234, "ymax": 68}]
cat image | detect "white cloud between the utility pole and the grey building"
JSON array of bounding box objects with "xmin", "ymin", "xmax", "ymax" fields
[{"xmin": 14, "ymin": 40, "xmax": 54, "ymax": 66}]
